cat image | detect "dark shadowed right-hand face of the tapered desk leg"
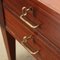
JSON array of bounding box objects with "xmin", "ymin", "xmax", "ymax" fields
[{"xmin": 6, "ymin": 32, "xmax": 16, "ymax": 60}]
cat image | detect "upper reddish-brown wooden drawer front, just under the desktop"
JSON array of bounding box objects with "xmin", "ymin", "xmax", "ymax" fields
[{"xmin": 4, "ymin": 0, "xmax": 60, "ymax": 48}]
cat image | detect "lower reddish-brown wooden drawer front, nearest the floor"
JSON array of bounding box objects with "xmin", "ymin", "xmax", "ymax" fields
[{"xmin": 4, "ymin": 8, "xmax": 60, "ymax": 60}]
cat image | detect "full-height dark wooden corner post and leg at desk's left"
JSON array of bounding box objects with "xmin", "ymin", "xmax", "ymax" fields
[{"xmin": 0, "ymin": 0, "xmax": 16, "ymax": 60}]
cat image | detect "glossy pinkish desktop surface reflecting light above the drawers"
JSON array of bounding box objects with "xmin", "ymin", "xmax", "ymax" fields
[{"xmin": 37, "ymin": 0, "xmax": 60, "ymax": 13}]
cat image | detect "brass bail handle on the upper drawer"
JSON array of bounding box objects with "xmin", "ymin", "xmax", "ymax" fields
[{"xmin": 20, "ymin": 7, "xmax": 39, "ymax": 29}]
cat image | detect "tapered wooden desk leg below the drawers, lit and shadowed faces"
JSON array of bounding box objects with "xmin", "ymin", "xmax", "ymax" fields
[{"xmin": 1, "ymin": 26, "xmax": 16, "ymax": 60}]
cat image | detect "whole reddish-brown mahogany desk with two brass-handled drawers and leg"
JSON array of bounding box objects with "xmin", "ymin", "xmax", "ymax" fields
[{"xmin": 0, "ymin": 0, "xmax": 60, "ymax": 60}]
